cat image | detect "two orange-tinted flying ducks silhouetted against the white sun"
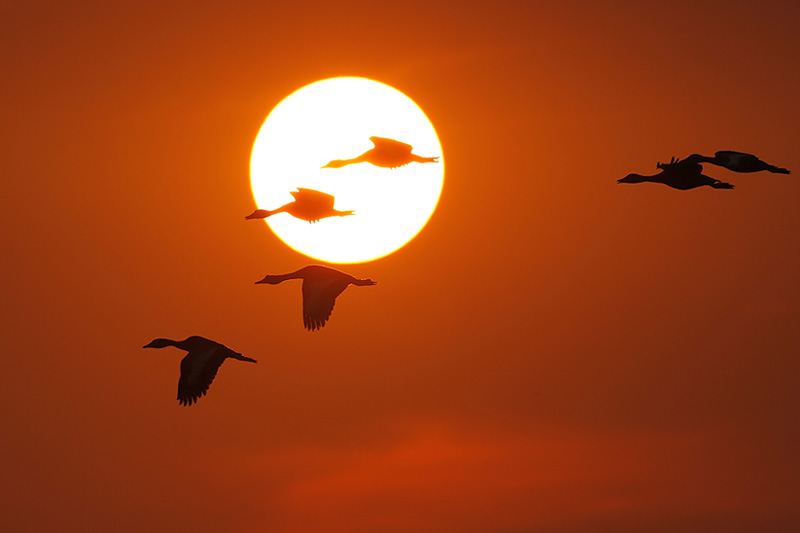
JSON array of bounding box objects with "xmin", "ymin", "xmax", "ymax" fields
[{"xmin": 244, "ymin": 136, "xmax": 439, "ymax": 223}]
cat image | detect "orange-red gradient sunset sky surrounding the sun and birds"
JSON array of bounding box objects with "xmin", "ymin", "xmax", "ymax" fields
[{"xmin": 0, "ymin": 0, "xmax": 800, "ymax": 533}]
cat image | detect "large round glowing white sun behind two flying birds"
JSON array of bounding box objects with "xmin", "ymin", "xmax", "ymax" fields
[{"xmin": 250, "ymin": 77, "xmax": 444, "ymax": 263}]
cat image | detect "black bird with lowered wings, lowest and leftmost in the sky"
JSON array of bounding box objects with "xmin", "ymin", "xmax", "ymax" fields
[{"xmin": 143, "ymin": 335, "xmax": 258, "ymax": 406}]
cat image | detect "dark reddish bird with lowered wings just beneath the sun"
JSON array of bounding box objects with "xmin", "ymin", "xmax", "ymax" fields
[{"xmin": 256, "ymin": 265, "xmax": 377, "ymax": 331}]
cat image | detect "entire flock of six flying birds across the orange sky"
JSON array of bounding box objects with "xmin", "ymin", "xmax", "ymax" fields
[{"xmin": 144, "ymin": 143, "xmax": 789, "ymax": 406}]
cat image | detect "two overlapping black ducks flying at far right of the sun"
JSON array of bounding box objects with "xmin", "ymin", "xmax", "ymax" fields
[{"xmin": 617, "ymin": 150, "xmax": 789, "ymax": 191}]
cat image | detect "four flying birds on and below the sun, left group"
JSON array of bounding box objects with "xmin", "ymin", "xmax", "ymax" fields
[{"xmin": 144, "ymin": 137, "xmax": 439, "ymax": 406}]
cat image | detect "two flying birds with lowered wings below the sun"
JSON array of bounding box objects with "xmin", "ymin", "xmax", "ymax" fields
[{"xmin": 143, "ymin": 265, "xmax": 376, "ymax": 406}]
